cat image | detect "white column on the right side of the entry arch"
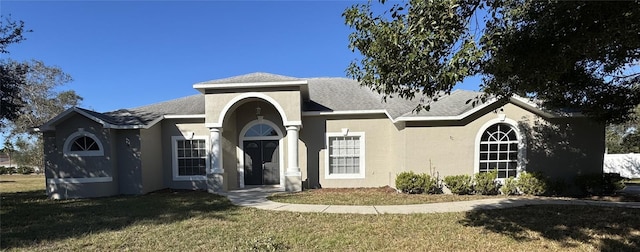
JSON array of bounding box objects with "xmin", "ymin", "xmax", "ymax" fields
[{"xmin": 285, "ymin": 125, "xmax": 302, "ymax": 192}]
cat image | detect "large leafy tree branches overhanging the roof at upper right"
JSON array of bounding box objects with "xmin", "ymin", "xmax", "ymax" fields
[{"xmin": 343, "ymin": 0, "xmax": 640, "ymax": 122}]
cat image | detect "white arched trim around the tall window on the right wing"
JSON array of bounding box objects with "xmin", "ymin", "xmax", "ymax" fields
[{"xmin": 473, "ymin": 117, "xmax": 527, "ymax": 182}]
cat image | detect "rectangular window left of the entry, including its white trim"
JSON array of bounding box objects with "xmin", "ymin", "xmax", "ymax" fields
[{"xmin": 172, "ymin": 136, "xmax": 209, "ymax": 180}]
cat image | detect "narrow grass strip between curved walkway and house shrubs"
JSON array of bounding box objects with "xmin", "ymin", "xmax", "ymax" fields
[{"xmin": 268, "ymin": 187, "xmax": 505, "ymax": 206}]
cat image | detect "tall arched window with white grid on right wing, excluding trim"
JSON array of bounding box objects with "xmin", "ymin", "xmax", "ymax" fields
[{"xmin": 478, "ymin": 123, "xmax": 518, "ymax": 178}]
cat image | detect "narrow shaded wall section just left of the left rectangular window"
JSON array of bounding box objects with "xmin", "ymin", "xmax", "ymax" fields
[{"xmin": 140, "ymin": 123, "xmax": 165, "ymax": 193}]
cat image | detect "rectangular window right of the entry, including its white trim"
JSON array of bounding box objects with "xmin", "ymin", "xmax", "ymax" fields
[{"xmin": 325, "ymin": 132, "xmax": 365, "ymax": 179}]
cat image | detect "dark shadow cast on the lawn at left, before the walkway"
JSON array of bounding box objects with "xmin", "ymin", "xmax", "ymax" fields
[{"xmin": 0, "ymin": 190, "xmax": 238, "ymax": 249}]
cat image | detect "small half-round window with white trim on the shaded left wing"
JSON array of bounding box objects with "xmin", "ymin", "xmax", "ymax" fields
[{"xmin": 64, "ymin": 129, "xmax": 104, "ymax": 156}]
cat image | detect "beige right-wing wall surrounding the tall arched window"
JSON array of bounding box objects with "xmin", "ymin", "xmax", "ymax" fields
[{"xmin": 400, "ymin": 103, "xmax": 604, "ymax": 183}]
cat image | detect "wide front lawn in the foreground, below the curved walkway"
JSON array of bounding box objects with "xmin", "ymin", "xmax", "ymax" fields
[{"xmin": 0, "ymin": 175, "xmax": 640, "ymax": 251}]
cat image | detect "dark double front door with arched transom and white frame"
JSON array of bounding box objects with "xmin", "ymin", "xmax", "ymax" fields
[{"xmin": 238, "ymin": 119, "xmax": 284, "ymax": 188}]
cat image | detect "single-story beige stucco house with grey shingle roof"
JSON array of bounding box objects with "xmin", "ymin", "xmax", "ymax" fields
[{"xmin": 40, "ymin": 73, "xmax": 605, "ymax": 199}]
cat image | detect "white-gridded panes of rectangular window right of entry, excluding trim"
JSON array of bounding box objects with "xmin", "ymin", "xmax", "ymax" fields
[{"xmin": 329, "ymin": 136, "xmax": 361, "ymax": 174}]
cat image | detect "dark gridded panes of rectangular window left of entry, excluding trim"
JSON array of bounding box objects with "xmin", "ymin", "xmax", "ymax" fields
[{"xmin": 176, "ymin": 139, "xmax": 207, "ymax": 176}]
